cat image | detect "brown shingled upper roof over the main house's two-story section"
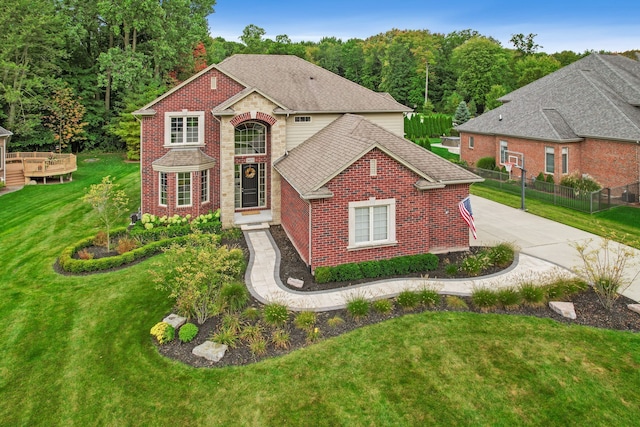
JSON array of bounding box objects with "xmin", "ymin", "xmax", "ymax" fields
[{"xmin": 134, "ymin": 55, "xmax": 413, "ymax": 115}]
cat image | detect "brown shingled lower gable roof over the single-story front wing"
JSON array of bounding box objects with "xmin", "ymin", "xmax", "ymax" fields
[{"xmin": 274, "ymin": 114, "xmax": 483, "ymax": 199}]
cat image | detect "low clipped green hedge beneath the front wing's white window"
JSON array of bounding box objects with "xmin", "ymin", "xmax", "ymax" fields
[{"xmin": 315, "ymin": 254, "xmax": 439, "ymax": 283}]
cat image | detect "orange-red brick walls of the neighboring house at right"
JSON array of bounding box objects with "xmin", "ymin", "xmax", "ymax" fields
[{"xmin": 460, "ymin": 133, "xmax": 640, "ymax": 187}]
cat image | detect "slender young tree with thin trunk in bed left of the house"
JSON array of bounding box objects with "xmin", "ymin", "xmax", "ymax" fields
[{"xmin": 83, "ymin": 176, "xmax": 129, "ymax": 251}]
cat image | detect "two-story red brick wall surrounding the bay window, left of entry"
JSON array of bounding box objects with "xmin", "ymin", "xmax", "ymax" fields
[{"xmin": 140, "ymin": 69, "xmax": 243, "ymax": 216}]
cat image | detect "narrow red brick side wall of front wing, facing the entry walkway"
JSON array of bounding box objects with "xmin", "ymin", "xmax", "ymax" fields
[{"xmin": 280, "ymin": 179, "xmax": 309, "ymax": 265}]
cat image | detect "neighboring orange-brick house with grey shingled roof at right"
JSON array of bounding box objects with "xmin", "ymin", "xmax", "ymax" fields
[{"xmin": 457, "ymin": 53, "xmax": 640, "ymax": 191}]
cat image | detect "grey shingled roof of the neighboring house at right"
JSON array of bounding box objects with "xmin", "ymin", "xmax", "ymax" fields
[{"xmin": 457, "ymin": 53, "xmax": 640, "ymax": 142}]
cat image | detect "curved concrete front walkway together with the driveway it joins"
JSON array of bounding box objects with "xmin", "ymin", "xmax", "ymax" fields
[{"xmin": 245, "ymin": 197, "xmax": 640, "ymax": 311}]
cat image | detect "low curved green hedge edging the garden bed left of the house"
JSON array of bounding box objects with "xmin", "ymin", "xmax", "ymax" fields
[{"xmin": 58, "ymin": 230, "xmax": 220, "ymax": 273}]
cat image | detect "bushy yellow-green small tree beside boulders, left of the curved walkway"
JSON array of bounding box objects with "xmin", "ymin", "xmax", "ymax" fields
[{"xmin": 151, "ymin": 234, "xmax": 245, "ymax": 324}]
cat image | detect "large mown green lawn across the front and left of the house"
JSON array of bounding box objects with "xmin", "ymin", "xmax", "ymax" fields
[{"xmin": 0, "ymin": 155, "xmax": 640, "ymax": 426}]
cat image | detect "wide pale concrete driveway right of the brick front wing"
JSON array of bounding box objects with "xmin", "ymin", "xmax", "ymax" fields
[{"xmin": 470, "ymin": 196, "xmax": 640, "ymax": 301}]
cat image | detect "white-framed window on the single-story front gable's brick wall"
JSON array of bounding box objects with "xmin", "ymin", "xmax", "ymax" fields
[{"xmin": 349, "ymin": 199, "xmax": 397, "ymax": 249}]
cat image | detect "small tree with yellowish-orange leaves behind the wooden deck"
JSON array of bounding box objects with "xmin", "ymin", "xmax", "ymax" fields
[{"xmin": 44, "ymin": 86, "xmax": 87, "ymax": 152}]
